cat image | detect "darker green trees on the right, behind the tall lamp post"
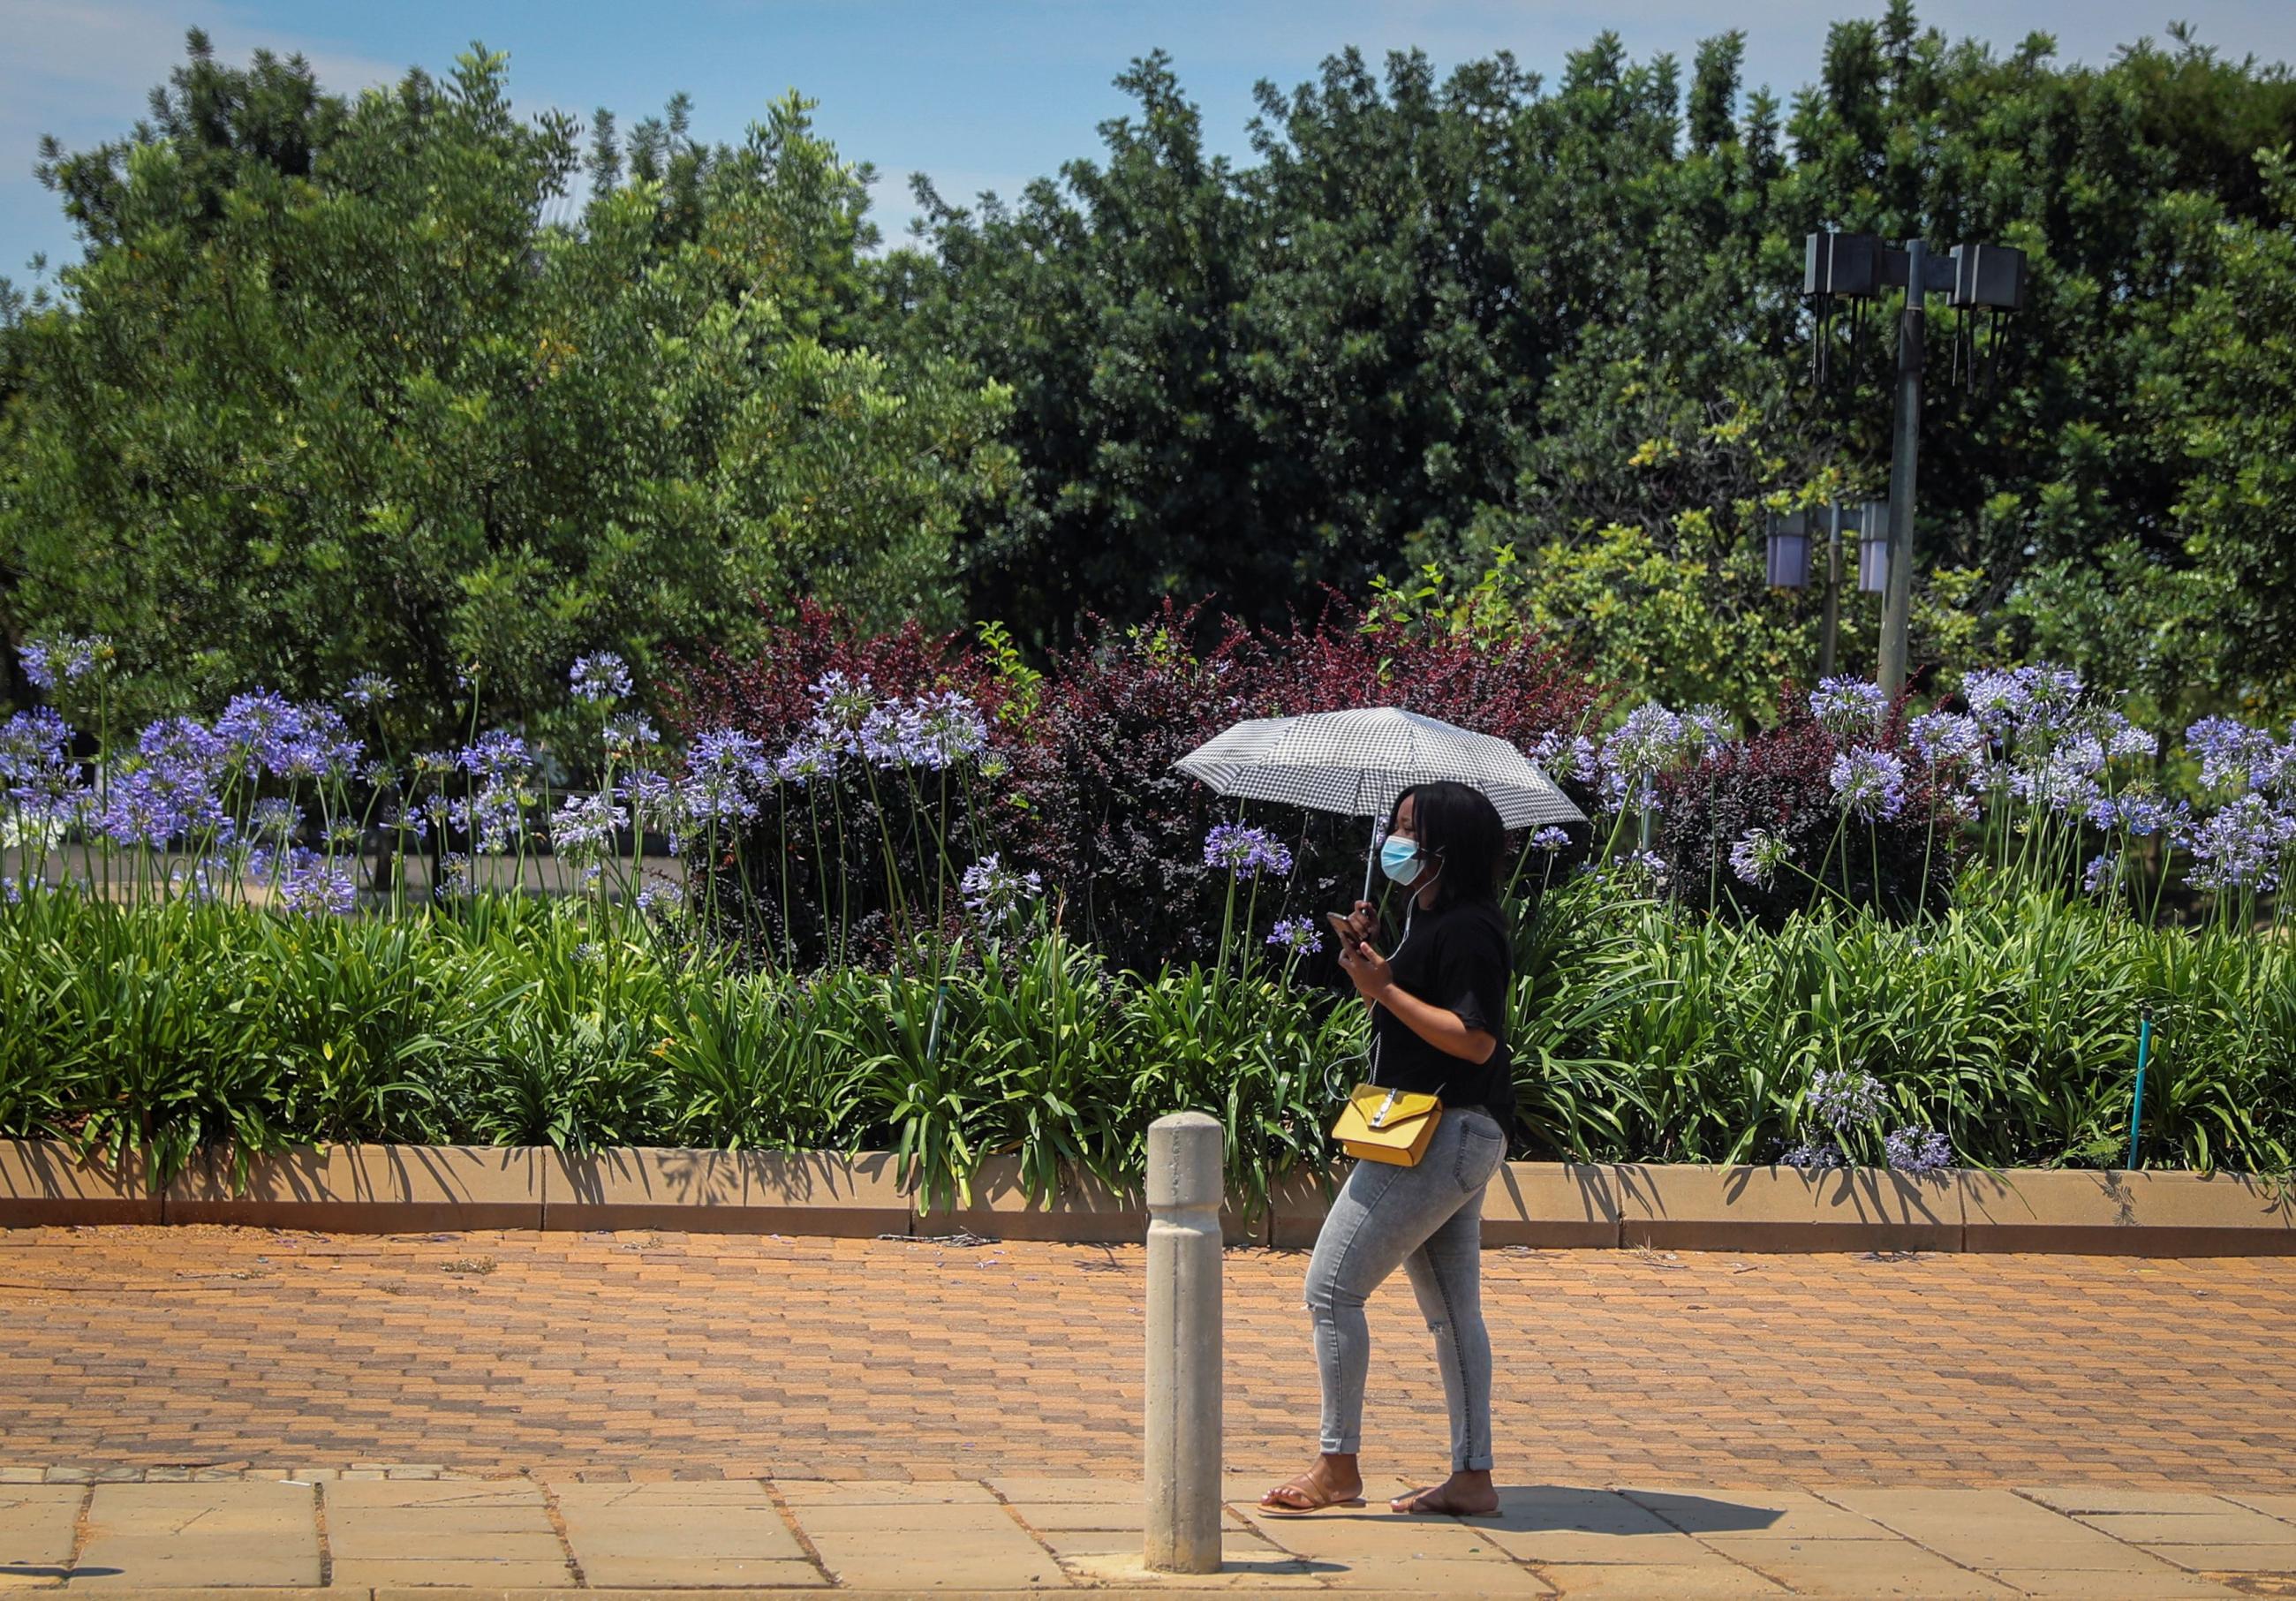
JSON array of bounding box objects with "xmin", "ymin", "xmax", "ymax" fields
[{"xmin": 888, "ymin": 15, "xmax": 2296, "ymax": 714}]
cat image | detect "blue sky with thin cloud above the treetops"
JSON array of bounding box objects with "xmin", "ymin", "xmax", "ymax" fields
[{"xmin": 0, "ymin": 0, "xmax": 2296, "ymax": 285}]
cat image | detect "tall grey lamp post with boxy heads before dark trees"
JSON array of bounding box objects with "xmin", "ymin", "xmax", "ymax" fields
[{"xmin": 1802, "ymin": 234, "xmax": 2025, "ymax": 696}]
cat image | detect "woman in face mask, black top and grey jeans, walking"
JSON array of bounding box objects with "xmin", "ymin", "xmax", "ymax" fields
[{"xmin": 1260, "ymin": 783, "xmax": 1515, "ymax": 1516}]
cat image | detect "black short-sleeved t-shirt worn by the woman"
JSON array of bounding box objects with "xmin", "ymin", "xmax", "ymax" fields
[{"xmin": 1371, "ymin": 901, "xmax": 1515, "ymax": 1137}]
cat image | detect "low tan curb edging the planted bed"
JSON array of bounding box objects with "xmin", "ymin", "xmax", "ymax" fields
[{"xmin": 0, "ymin": 1139, "xmax": 2296, "ymax": 1257}]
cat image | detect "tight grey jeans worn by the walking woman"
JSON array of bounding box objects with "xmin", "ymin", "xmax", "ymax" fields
[{"xmin": 1306, "ymin": 1107, "xmax": 1507, "ymax": 1472}]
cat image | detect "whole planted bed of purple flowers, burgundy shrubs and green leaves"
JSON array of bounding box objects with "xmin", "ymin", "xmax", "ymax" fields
[{"xmin": 0, "ymin": 614, "xmax": 2296, "ymax": 1206}]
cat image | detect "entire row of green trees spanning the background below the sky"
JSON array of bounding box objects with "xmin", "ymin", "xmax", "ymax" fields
[{"xmin": 0, "ymin": 0, "xmax": 2296, "ymax": 735}]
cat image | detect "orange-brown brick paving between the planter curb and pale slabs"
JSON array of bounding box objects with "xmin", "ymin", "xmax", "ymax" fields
[{"xmin": 0, "ymin": 1227, "xmax": 2296, "ymax": 1495}]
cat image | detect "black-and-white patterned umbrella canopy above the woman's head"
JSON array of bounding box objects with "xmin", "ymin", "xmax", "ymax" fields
[{"xmin": 1174, "ymin": 706, "xmax": 1587, "ymax": 829}]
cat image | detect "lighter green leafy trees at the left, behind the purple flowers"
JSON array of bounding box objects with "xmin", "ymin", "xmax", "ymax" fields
[{"xmin": 0, "ymin": 37, "xmax": 1006, "ymax": 729}]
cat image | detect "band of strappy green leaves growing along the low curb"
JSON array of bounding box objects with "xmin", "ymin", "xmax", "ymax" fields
[{"xmin": 0, "ymin": 882, "xmax": 2296, "ymax": 1206}]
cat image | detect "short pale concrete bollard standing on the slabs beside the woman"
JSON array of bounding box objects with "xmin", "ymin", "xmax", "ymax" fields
[{"xmin": 1141, "ymin": 1112, "xmax": 1224, "ymax": 1574}]
